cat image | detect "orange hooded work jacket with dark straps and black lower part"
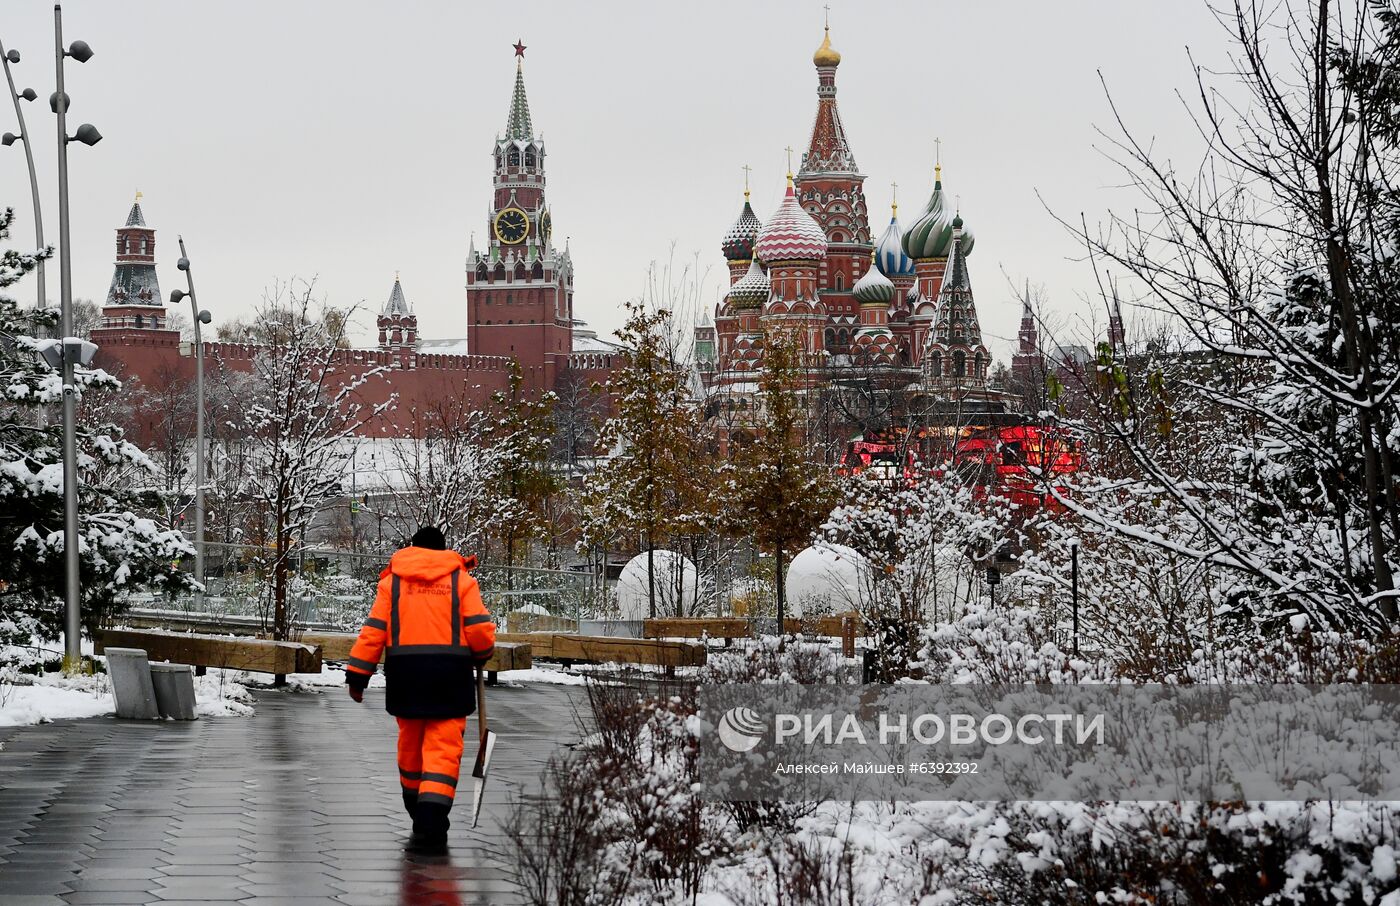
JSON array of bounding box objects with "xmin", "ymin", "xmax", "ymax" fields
[{"xmin": 346, "ymin": 548, "xmax": 496, "ymax": 717}]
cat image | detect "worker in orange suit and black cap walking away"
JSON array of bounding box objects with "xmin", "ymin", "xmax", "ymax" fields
[{"xmin": 346, "ymin": 527, "xmax": 496, "ymax": 847}]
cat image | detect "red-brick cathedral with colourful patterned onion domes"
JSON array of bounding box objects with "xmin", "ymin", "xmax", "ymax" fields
[{"xmin": 696, "ymin": 28, "xmax": 991, "ymax": 395}]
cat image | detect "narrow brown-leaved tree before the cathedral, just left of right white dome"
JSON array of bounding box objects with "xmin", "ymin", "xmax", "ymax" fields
[{"xmin": 725, "ymin": 329, "xmax": 837, "ymax": 626}]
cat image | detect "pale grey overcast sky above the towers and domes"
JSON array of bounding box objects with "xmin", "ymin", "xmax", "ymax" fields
[{"xmin": 0, "ymin": 0, "xmax": 1226, "ymax": 360}]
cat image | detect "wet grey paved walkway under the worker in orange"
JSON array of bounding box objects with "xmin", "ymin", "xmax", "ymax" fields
[{"xmin": 0, "ymin": 685, "xmax": 582, "ymax": 906}]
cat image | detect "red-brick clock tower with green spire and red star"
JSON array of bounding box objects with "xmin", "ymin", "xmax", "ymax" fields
[{"xmin": 466, "ymin": 42, "xmax": 574, "ymax": 391}]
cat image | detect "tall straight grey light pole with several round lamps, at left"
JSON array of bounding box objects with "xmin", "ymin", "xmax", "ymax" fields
[{"xmin": 49, "ymin": 3, "xmax": 102, "ymax": 669}]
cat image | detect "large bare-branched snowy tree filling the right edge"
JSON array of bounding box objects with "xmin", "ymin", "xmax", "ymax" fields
[{"xmin": 1065, "ymin": 0, "xmax": 1400, "ymax": 632}]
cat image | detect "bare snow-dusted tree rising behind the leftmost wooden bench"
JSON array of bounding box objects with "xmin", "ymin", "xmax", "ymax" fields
[{"xmin": 218, "ymin": 283, "xmax": 391, "ymax": 639}]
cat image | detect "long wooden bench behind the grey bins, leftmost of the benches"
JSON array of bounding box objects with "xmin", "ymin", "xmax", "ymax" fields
[{"xmin": 94, "ymin": 629, "xmax": 321, "ymax": 675}]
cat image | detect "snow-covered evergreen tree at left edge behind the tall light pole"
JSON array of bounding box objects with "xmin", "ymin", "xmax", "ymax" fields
[{"xmin": 0, "ymin": 209, "xmax": 193, "ymax": 637}]
